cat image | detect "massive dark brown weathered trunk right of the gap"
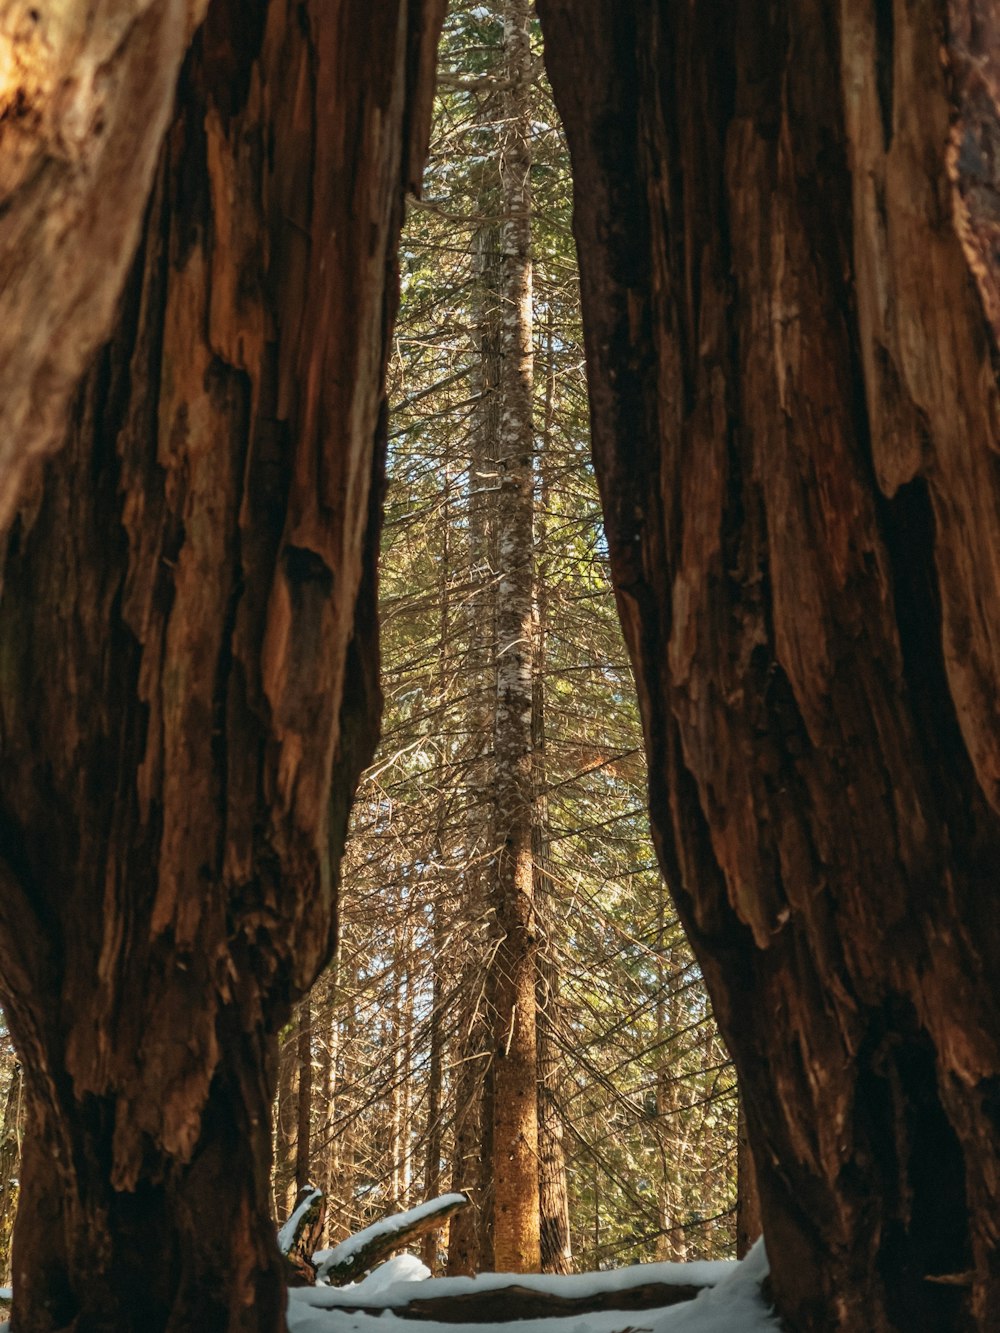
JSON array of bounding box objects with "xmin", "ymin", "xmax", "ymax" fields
[{"xmin": 539, "ymin": 0, "xmax": 1000, "ymax": 1333}]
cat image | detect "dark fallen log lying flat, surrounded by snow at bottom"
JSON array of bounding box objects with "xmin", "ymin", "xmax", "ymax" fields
[{"xmin": 326, "ymin": 1282, "xmax": 704, "ymax": 1324}]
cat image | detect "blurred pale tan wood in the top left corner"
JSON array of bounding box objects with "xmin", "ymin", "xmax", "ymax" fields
[{"xmin": 0, "ymin": 0, "xmax": 207, "ymax": 532}]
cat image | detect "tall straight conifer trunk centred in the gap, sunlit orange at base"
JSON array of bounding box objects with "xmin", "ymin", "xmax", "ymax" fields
[{"xmin": 488, "ymin": 0, "xmax": 540, "ymax": 1273}]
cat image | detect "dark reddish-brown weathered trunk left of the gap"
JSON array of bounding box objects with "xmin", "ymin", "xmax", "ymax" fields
[{"xmin": 0, "ymin": 0, "xmax": 443, "ymax": 1333}]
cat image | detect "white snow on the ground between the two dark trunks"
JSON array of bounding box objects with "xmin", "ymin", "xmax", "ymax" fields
[{"xmin": 288, "ymin": 1241, "xmax": 779, "ymax": 1333}]
